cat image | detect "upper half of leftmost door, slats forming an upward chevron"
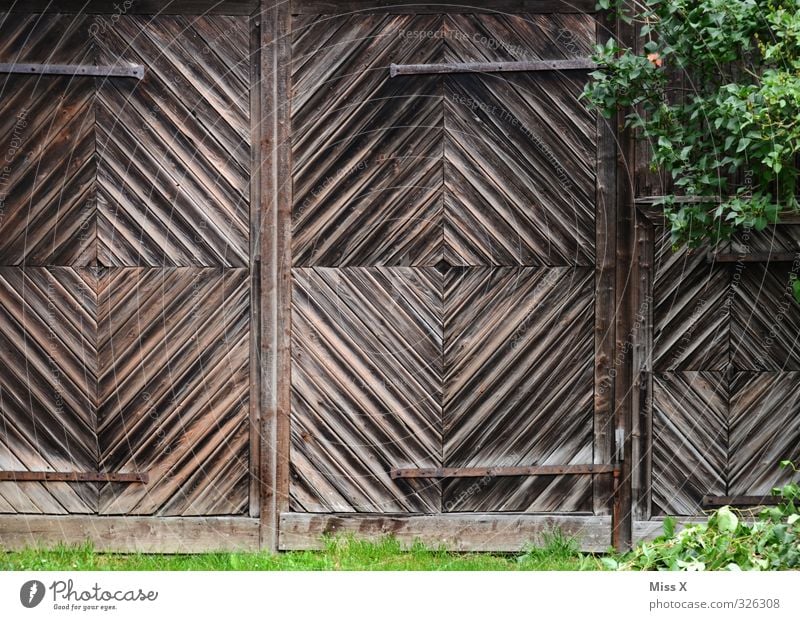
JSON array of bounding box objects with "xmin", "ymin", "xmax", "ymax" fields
[{"xmin": 0, "ymin": 15, "xmax": 250, "ymax": 267}]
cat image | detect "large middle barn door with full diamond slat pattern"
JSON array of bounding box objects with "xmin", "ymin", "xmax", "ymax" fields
[{"xmin": 281, "ymin": 3, "xmax": 614, "ymax": 548}]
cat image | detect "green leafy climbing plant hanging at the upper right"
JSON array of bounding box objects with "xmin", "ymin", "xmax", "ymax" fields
[{"xmin": 584, "ymin": 0, "xmax": 800, "ymax": 247}]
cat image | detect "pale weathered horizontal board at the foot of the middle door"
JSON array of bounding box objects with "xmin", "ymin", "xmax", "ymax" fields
[{"xmin": 279, "ymin": 513, "xmax": 611, "ymax": 551}]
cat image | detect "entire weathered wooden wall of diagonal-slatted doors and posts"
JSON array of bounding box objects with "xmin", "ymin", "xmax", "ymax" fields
[{"xmin": 0, "ymin": 0, "xmax": 800, "ymax": 552}]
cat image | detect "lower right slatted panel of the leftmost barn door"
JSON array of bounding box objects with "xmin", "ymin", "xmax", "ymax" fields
[{"xmin": 98, "ymin": 268, "xmax": 249, "ymax": 515}]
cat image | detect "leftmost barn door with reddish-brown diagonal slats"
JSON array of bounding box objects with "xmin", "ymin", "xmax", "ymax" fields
[{"xmin": 0, "ymin": 13, "xmax": 253, "ymax": 520}]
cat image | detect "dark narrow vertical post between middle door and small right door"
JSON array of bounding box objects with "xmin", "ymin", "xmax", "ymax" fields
[{"xmin": 613, "ymin": 1, "xmax": 639, "ymax": 549}]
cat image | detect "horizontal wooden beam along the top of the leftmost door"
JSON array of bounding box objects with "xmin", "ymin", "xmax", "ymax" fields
[{"xmin": 0, "ymin": 0, "xmax": 258, "ymax": 15}]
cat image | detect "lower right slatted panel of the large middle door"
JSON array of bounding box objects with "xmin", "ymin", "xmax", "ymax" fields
[{"xmin": 444, "ymin": 268, "xmax": 594, "ymax": 512}]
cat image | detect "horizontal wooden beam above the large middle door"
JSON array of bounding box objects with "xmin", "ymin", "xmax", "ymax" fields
[{"xmin": 292, "ymin": 0, "xmax": 595, "ymax": 15}]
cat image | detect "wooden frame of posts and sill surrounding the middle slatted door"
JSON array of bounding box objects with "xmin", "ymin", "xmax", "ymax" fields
[{"xmin": 262, "ymin": 0, "xmax": 631, "ymax": 551}]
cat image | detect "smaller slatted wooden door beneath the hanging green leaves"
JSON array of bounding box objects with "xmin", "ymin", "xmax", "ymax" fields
[{"xmin": 634, "ymin": 215, "xmax": 800, "ymax": 537}]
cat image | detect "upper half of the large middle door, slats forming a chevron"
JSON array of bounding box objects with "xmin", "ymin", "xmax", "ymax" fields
[{"xmin": 292, "ymin": 15, "xmax": 596, "ymax": 267}]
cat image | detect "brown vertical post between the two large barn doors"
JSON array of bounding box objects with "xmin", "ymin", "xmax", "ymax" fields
[{"xmin": 257, "ymin": 0, "xmax": 292, "ymax": 551}]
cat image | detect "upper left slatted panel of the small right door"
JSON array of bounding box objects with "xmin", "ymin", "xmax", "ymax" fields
[{"xmin": 652, "ymin": 227, "xmax": 731, "ymax": 372}]
